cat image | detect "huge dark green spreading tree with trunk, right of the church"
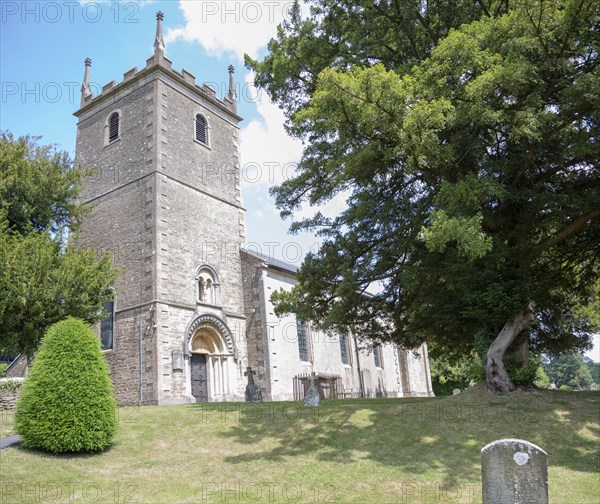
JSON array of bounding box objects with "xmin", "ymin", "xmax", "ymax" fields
[{"xmin": 246, "ymin": 0, "xmax": 600, "ymax": 393}]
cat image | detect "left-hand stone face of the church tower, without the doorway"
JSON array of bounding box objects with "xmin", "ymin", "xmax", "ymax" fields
[{"xmin": 76, "ymin": 76, "xmax": 157, "ymax": 404}]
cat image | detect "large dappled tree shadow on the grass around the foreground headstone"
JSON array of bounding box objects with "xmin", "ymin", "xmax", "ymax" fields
[{"xmin": 189, "ymin": 392, "xmax": 600, "ymax": 489}]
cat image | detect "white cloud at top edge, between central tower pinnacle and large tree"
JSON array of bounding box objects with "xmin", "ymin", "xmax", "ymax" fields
[{"xmin": 165, "ymin": 0, "xmax": 293, "ymax": 59}]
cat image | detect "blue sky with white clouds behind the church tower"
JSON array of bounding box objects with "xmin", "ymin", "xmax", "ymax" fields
[{"xmin": 0, "ymin": 0, "xmax": 600, "ymax": 361}]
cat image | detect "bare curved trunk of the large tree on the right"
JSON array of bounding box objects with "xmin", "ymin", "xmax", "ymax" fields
[{"xmin": 485, "ymin": 303, "xmax": 535, "ymax": 394}]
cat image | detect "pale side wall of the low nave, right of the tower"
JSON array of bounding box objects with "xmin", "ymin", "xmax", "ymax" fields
[{"xmin": 241, "ymin": 252, "xmax": 431, "ymax": 401}]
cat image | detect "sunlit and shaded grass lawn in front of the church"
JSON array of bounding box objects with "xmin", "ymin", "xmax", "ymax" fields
[{"xmin": 0, "ymin": 389, "xmax": 600, "ymax": 504}]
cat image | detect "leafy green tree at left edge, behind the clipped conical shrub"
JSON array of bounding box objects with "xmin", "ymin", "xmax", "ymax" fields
[{"xmin": 0, "ymin": 134, "xmax": 119, "ymax": 355}]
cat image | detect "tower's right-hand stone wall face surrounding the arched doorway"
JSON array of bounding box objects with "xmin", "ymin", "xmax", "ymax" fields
[{"xmin": 156, "ymin": 76, "xmax": 246, "ymax": 403}]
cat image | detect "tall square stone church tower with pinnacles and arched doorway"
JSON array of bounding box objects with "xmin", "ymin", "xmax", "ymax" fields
[{"xmin": 75, "ymin": 12, "xmax": 248, "ymax": 404}]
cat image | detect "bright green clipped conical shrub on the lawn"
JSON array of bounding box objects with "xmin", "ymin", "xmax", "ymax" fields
[{"xmin": 15, "ymin": 318, "xmax": 117, "ymax": 453}]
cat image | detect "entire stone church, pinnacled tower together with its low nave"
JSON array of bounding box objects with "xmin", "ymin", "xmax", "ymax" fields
[{"xmin": 75, "ymin": 12, "xmax": 433, "ymax": 404}]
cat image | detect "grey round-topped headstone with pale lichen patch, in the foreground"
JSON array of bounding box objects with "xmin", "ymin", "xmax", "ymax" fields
[{"xmin": 481, "ymin": 439, "xmax": 548, "ymax": 504}]
